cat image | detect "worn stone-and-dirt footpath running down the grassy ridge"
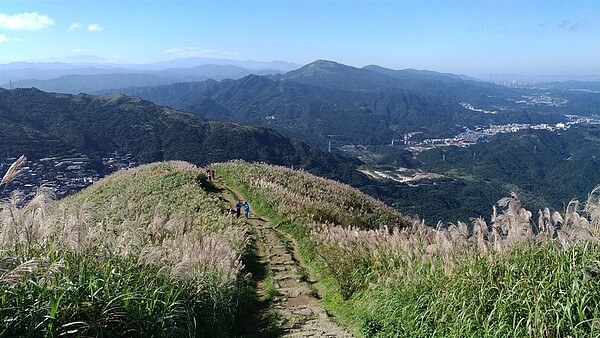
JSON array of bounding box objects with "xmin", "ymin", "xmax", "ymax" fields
[{"xmin": 213, "ymin": 180, "xmax": 353, "ymax": 337}]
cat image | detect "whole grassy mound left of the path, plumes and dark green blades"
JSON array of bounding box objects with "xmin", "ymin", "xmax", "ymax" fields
[{"xmin": 0, "ymin": 162, "xmax": 253, "ymax": 337}]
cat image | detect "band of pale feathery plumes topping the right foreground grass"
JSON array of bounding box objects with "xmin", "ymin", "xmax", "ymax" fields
[{"xmin": 312, "ymin": 186, "xmax": 600, "ymax": 275}]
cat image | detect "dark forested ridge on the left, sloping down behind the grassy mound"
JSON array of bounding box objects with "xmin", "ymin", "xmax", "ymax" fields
[{"xmin": 0, "ymin": 89, "xmax": 366, "ymax": 182}]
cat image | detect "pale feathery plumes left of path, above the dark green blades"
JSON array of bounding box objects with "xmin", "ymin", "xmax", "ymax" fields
[{"xmin": 0, "ymin": 162, "xmax": 249, "ymax": 282}]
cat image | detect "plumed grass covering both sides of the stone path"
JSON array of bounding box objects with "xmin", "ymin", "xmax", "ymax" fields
[{"xmin": 0, "ymin": 158, "xmax": 600, "ymax": 337}]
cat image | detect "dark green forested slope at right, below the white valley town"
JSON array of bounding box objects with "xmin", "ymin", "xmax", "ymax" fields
[{"xmin": 360, "ymin": 125, "xmax": 600, "ymax": 224}]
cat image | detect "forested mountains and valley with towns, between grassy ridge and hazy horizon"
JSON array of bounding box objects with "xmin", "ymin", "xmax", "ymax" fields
[{"xmin": 0, "ymin": 60, "xmax": 600, "ymax": 223}]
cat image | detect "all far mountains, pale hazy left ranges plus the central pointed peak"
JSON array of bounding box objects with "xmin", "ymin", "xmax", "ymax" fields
[{"xmin": 0, "ymin": 58, "xmax": 600, "ymax": 144}]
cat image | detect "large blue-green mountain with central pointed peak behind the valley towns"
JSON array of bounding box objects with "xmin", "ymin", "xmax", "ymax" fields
[{"xmin": 111, "ymin": 60, "xmax": 599, "ymax": 148}]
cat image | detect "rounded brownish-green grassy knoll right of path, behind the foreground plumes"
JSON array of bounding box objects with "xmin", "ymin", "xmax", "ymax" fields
[{"xmin": 215, "ymin": 161, "xmax": 409, "ymax": 229}]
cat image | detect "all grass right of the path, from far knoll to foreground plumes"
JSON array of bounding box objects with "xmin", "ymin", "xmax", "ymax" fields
[{"xmin": 216, "ymin": 162, "xmax": 600, "ymax": 337}]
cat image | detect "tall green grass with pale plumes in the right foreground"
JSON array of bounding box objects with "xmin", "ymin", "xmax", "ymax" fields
[{"xmin": 322, "ymin": 188, "xmax": 600, "ymax": 337}]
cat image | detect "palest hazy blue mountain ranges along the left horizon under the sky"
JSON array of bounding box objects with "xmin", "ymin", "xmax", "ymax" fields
[{"xmin": 0, "ymin": 58, "xmax": 301, "ymax": 90}]
